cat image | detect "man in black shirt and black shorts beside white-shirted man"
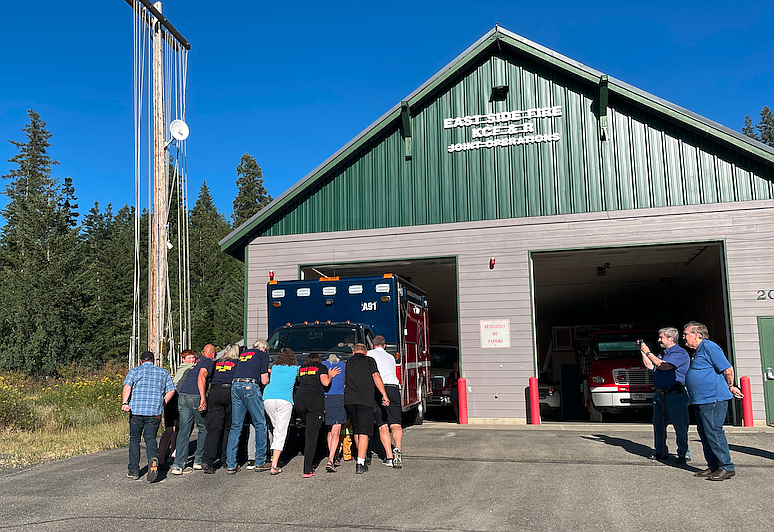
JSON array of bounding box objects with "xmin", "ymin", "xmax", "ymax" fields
[{"xmin": 344, "ymin": 344, "xmax": 390, "ymax": 475}]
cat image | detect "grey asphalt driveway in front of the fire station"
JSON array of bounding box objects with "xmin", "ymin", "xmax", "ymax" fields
[{"xmin": 0, "ymin": 422, "xmax": 774, "ymax": 532}]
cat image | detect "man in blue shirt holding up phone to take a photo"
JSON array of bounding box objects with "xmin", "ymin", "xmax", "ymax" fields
[{"xmin": 637, "ymin": 327, "xmax": 691, "ymax": 464}]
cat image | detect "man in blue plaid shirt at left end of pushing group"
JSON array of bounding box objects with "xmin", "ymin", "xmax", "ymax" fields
[{"xmin": 121, "ymin": 351, "xmax": 175, "ymax": 482}]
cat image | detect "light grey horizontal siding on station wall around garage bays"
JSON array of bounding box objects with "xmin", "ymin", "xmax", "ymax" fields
[{"xmin": 247, "ymin": 200, "xmax": 774, "ymax": 422}]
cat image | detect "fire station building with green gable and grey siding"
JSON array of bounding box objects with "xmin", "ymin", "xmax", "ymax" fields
[{"xmin": 221, "ymin": 27, "xmax": 774, "ymax": 424}]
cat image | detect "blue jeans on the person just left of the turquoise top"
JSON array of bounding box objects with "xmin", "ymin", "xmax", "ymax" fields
[{"xmin": 226, "ymin": 382, "xmax": 266, "ymax": 469}]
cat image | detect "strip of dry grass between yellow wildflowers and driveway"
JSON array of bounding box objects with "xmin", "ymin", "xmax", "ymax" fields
[{"xmin": 0, "ymin": 419, "xmax": 129, "ymax": 467}]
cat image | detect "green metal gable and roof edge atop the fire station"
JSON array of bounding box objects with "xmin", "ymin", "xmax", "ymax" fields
[{"xmin": 220, "ymin": 27, "xmax": 774, "ymax": 258}]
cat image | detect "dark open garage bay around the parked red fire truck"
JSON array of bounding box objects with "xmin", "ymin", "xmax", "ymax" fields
[{"xmin": 531, "ymin": 242, "xmax": 733, "ymax": 421}]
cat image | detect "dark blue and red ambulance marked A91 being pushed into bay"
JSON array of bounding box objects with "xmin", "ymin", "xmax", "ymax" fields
[{"xmin": 267, "ymin": 273, "xmax": 431, "ymax": 424}]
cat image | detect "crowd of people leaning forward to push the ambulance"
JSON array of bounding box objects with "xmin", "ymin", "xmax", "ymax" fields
[{"xmin": 122, "ymin": 336, "xmax": 403, "ymax": 482}]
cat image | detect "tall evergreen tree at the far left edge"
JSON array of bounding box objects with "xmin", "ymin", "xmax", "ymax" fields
[{"xmin": 0, "ymin": 111, "xmax": 83, "ymax": 375}]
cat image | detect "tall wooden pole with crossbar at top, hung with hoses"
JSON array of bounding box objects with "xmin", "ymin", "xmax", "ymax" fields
[{"xmin": 126, "ymin": 0, "xmax": 191, "ymax": 366}]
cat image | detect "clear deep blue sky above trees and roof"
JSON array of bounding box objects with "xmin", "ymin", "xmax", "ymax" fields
[{"xmin": 0, "ymin": 0, "xmax": 774, "ymax": 222}]
